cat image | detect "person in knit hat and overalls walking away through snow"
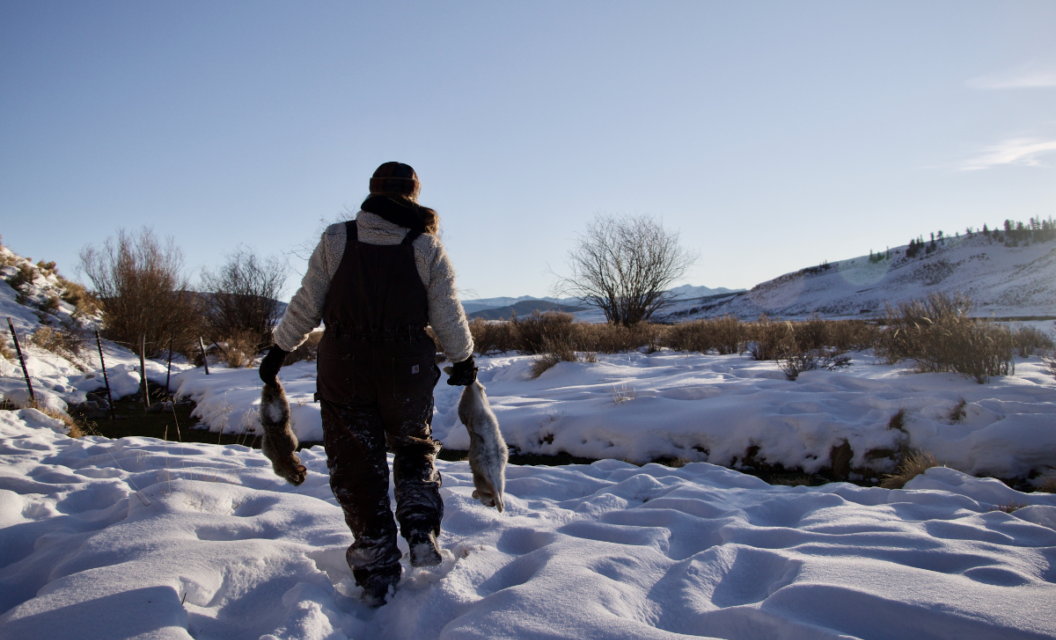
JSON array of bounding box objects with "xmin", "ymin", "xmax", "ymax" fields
[{"xmin": 260, "ymin": 163, "xmax": 476, "ymax": 606}]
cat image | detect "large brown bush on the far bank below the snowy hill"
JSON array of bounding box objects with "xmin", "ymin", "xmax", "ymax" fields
[{"xmin": 876, "ymin": 294, "xmax": 1014, "ymax": 384}]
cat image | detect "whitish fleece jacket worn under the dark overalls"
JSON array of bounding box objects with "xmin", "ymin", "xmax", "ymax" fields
[{"xmin": 275, "ymin": 211, "xmax": 473, "ymax": 362}]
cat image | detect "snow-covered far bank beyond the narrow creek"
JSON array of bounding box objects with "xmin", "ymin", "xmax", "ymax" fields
[{"xmin": 178, "ymin": 351, "xmax": 1056, "ymax": 477}]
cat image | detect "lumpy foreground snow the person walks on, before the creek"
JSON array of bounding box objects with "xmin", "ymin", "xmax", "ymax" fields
[{"xmin": 0, "ymin": 410, "xmax": 1056, "ymax": 640}]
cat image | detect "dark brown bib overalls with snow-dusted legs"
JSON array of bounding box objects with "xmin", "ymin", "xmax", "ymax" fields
[{"xmin": 318, "ymin": 221, "xmax": 444, "ymax": 585}]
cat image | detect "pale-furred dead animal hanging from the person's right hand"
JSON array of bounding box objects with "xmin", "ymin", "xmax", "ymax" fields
[{"xmin": 444, "ymin": 366, "xmax": 509, "ymax": 512}]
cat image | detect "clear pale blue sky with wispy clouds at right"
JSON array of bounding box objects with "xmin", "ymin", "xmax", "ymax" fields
[{"xmin": 0, "ymin": 0, "xmax": 1056, "ymax": 297}]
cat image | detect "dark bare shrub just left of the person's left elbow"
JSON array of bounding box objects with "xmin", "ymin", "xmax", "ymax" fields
[{"xmin": 202, "ymin": 247, "xmax": 289, "ymax": 353}]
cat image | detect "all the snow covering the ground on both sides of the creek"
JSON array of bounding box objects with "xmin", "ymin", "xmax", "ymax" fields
[{"xmin": 6, "ymin": 242, "xmax": 1056, "ymax": 640}]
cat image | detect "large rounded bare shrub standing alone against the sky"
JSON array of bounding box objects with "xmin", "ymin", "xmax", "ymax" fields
[{"xmin": 557, "ymin": 215, "xmax": 696, "ymax": 326}]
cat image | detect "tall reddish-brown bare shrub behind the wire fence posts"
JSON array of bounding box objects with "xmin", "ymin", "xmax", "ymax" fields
[{"xmin": 80, "ymin": 228, "xmax": 202, "ymax": 357}]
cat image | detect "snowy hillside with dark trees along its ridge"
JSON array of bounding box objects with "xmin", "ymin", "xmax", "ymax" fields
[{"xmin": 665, "ymin": 233, "xmax": 1056, "ymax": 321}]
